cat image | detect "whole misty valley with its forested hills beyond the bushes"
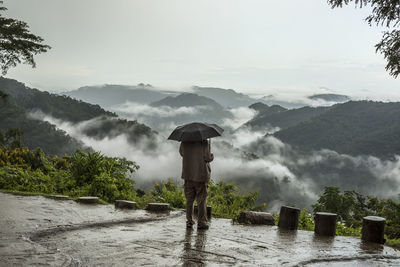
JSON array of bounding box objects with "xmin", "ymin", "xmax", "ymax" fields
[{"xmin": 1, "ymin": 78, "xmax": 400, "ymax": 211}]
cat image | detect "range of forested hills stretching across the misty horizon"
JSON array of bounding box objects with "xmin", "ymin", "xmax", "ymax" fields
[{"xmin": 0, "ymin": 78, "xmax": 400, "ymax": 161}]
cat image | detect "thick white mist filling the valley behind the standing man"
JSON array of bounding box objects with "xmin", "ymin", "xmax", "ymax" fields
[{"xmin": 31, "ymin": 109, "xmax": 400, "ymax": 214}]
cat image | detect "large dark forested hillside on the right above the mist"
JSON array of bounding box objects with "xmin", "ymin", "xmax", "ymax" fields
[{"xmin": 275, "ymin": 101, "xmax": 400, "ymax": 158}]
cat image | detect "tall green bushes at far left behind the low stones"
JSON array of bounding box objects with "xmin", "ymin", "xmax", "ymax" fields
[{"xmin": 0, "ymin": 148, "xmax": 138, "ymax": 202}]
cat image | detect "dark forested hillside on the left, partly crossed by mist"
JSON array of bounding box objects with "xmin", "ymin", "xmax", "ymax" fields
[{"xmin": 0, "ymin": 78, "xmax": 154, "ymax": 155}]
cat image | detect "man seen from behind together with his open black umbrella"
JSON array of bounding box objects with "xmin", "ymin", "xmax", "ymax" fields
[{"xmin": 168, "ymin": 122, "xmax": 223, "ymax": 229}]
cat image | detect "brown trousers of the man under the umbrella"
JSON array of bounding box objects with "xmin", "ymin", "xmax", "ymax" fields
[{"xmin": 184, "ymin": 180, "xmax": 208, "ymax": 225}]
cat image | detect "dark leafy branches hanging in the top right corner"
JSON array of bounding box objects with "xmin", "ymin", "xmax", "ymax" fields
[{"xmin": 328, "ymin": 0, "xmax": 400, "ymax": 78}]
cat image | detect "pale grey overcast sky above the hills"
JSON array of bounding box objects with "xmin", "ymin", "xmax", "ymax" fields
[{"xmin": 4, "ymin": 0, "xmax": 400, "ymax": 100}]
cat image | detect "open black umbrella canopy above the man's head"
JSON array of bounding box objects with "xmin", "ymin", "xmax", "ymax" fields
[{"xmin": 168, "ymin": 122, "xmax": 224, "ymax": 142}]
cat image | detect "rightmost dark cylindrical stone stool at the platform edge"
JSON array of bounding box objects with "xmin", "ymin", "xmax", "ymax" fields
[{"xmin": 361, "ymin": 216, "xmax": 386, "ymax": 244}]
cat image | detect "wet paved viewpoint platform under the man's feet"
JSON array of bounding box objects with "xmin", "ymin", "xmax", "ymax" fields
[{"xmin": 0, "ymin": 193, "xmax": 400, "ymax": 266}]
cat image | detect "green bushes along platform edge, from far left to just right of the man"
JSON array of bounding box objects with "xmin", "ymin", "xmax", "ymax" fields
[{"xmin": 0, "ymin": 148, "xmax": 265, "ymax": 218}]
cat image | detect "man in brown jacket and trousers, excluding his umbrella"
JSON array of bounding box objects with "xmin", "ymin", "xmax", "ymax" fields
[{"xmin": 179, "ymin": 140, "xmax": 214, "ymax": 229}]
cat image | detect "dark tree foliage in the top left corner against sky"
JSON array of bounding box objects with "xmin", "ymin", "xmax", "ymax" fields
[{"xmin": 0, "ymin": 1, "xmax": 51, "ymax": 75}]
